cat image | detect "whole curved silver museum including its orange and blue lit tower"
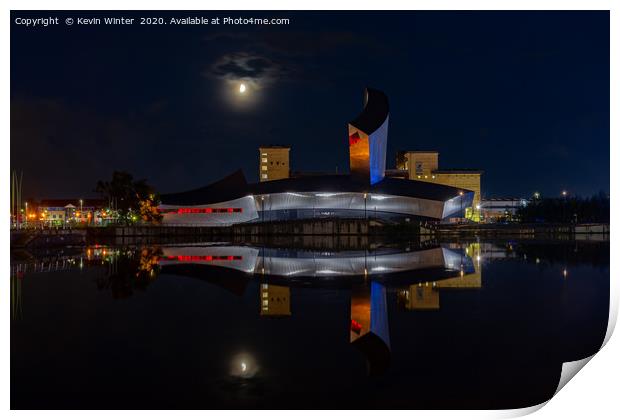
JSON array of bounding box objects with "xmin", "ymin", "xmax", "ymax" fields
[{"xmin": 159, "ymin": 89, "xmax": 474, "ymax": 226}]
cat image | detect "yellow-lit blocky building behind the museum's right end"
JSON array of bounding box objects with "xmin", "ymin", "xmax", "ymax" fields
[{"xmin": 390, "ymin": 150, "xmax": 483, "ymax": 222}]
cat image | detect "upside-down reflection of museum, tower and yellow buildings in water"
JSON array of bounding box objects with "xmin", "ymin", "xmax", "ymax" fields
[{"xmin": 159, "ymin": 244, "xmax": 472, "ymax": 376}]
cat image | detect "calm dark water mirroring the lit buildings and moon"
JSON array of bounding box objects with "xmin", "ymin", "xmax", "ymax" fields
[{"xmin": 11, "ymin": 241, "xmax": 609, "ymax": 409}]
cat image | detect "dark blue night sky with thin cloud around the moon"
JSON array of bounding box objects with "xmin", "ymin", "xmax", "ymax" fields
[{"xmin": 11, "ymin": 12, "xmax": 610, "ymax": 199}]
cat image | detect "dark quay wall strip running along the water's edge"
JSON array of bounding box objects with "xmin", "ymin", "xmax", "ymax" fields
[{"xmin": 11, "ymin": 219, "xmax": 610, "ymax": 249}]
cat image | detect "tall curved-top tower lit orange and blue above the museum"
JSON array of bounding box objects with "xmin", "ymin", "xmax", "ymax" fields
[{"xmin": 349, "ymin": 88, "xmax": 390, "ymax": 185}]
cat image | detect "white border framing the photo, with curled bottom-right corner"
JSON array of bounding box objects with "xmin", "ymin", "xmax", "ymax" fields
[{"xmin": 0, "ymin": 0, "xmax": 620, "ymax": 420}]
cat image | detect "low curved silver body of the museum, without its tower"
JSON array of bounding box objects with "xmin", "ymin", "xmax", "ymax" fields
[{"xmin": 159, "ymin": 175, "xmax": 473, "ymax": 226}]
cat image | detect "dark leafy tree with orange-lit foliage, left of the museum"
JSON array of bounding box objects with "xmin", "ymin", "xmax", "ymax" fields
[{"xmin": 95, "ymin": 171, "xmax": 161, "ymax": 223}]
